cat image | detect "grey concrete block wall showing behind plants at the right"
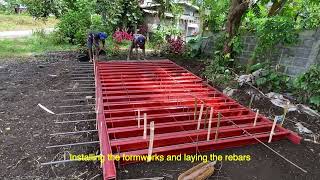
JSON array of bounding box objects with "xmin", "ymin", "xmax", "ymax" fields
[{"xmin": 203, "ymin": 28, "xmax": 320, "ymax": 76}]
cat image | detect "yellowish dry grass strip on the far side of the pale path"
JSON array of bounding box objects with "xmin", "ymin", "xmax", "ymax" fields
[{"xmin": 0, "ymin": 14, "xmax": 58, "ymax": 31}]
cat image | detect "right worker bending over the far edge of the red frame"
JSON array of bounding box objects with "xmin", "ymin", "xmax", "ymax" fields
[{"xmin": 127, "ymin": 34, "xmax": 146, "ymax": 60}]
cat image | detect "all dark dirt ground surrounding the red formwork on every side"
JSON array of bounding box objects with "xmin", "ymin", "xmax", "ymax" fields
[{"xmin": 0, "ymin": 52, "xmax": 320, "ymax": 180}]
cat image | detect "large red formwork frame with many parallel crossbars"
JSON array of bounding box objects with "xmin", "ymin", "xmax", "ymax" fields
[{"xmin": 95, "ymin": 60, "xmax": 301, "ymax": 179}]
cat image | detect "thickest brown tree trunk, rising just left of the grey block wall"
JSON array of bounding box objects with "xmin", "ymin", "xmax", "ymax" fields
[{"xmin": 223, "ymin": 0, "xmax": 249, "ymax": 54}]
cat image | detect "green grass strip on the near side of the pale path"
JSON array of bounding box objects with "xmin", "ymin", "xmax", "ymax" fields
[{"xmin": 0, "ymin": 35, "xmax": 77, "ymax": 58}]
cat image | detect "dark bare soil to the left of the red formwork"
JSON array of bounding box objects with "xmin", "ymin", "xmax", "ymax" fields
[{"xmin": 0, "ymin": 52, "xmax": 100, "ymax": 179}]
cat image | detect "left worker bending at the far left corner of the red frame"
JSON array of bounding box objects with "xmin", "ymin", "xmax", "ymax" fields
[{"xmin": 87, "ymin": 32, "xmax": 107, "ymax": 62}]
